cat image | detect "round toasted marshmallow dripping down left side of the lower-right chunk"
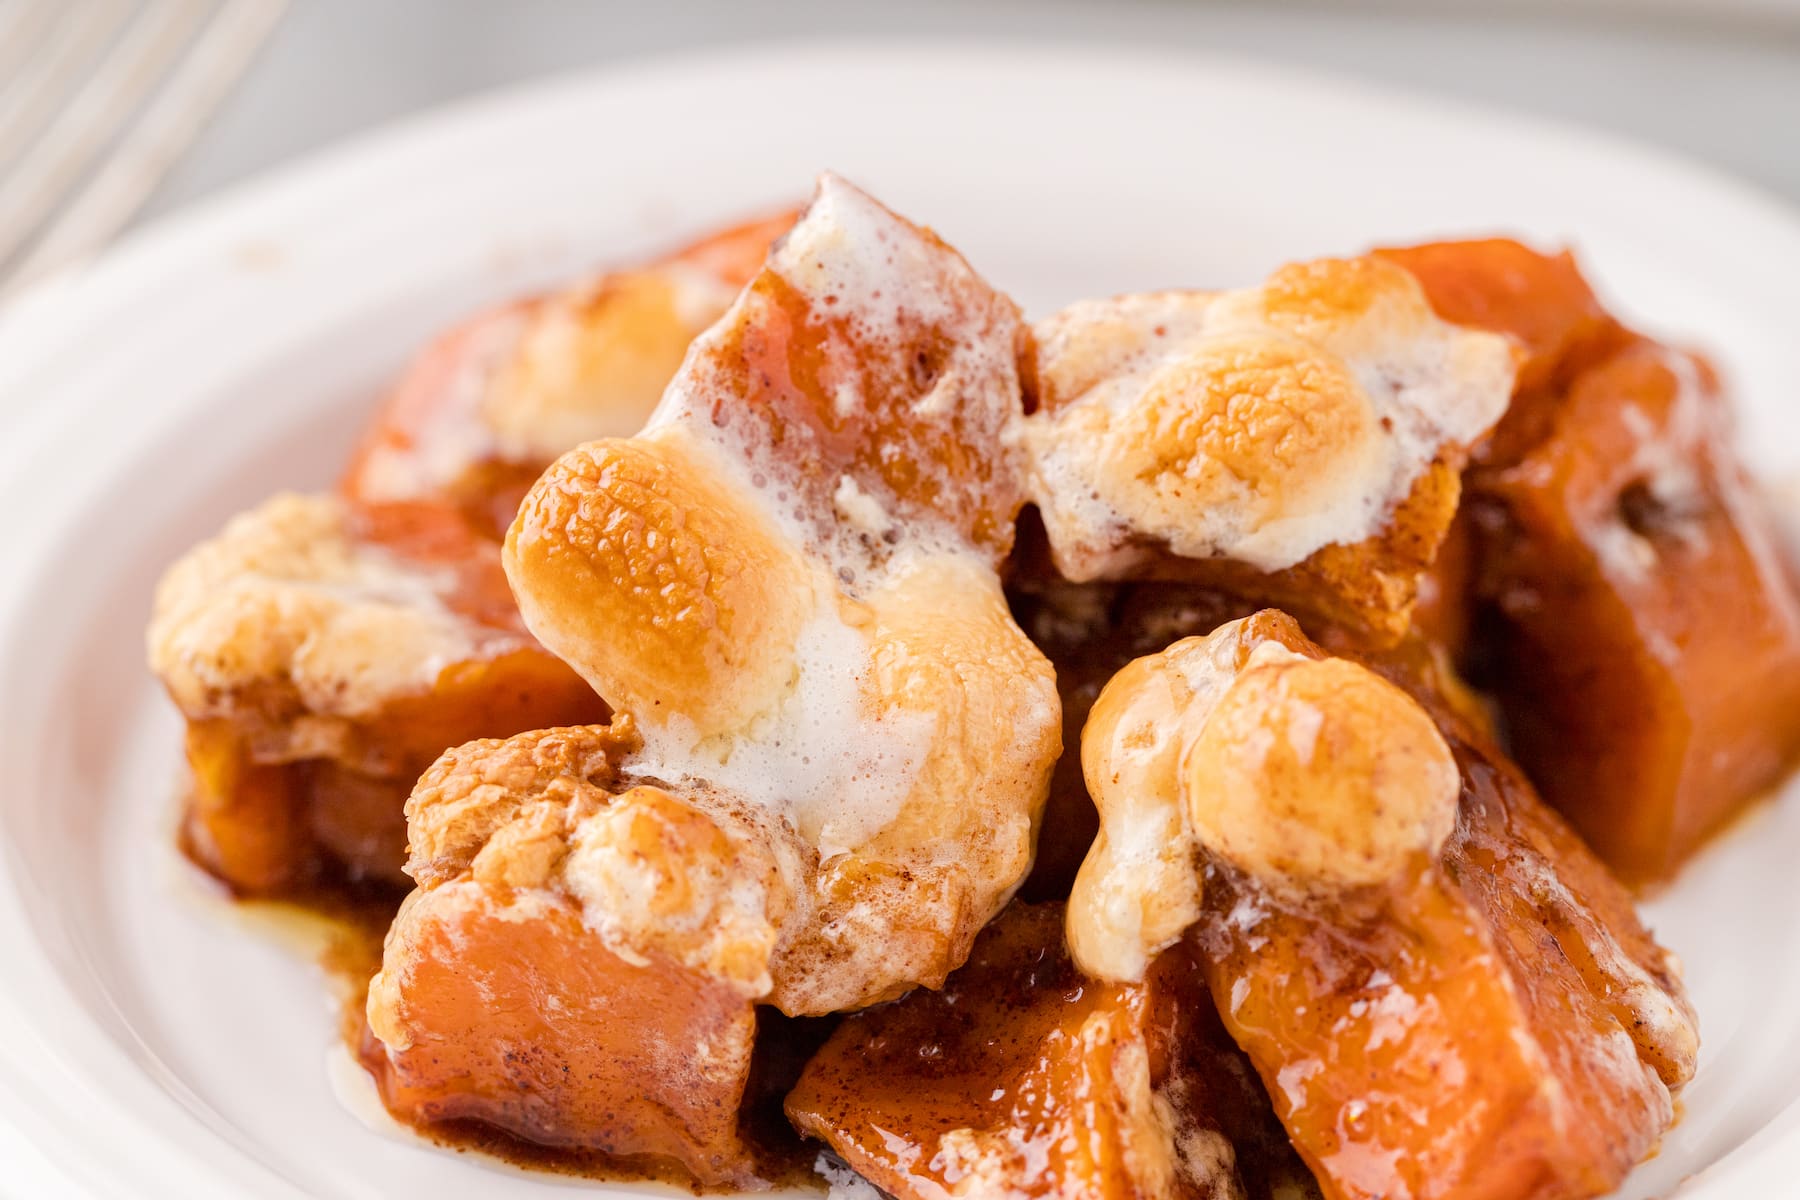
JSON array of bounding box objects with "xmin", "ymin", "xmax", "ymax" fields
[{"xmin": 1067, "ymin": 612, "xmax": 1462, "ymax": 979}]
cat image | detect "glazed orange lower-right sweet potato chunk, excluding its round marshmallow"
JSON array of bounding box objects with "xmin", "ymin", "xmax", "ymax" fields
[{"xmin": 1188, "ymin": 618, "xmax": 1696, "ymax": 1200}]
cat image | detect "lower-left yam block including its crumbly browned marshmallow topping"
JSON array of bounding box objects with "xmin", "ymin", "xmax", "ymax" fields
[{"xmin": 364, "ymin": 723, "xmax": 779, "ymax": 1187}]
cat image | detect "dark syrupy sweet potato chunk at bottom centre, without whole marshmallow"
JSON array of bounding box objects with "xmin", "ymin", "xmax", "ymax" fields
[{"xmin": 787, "ymin": 903, "xmax": 1310, "ymax": 1200}]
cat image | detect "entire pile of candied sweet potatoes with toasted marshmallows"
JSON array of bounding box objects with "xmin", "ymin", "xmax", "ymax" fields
[{"xmin": 149, "ymin": 175, "xmax": 1800, "ymax": 1200}]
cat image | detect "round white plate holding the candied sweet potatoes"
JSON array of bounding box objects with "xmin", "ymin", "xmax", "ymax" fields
[{"xmin": 0, "ymin": 43, "xmax": 1800, "ymax": 1200}]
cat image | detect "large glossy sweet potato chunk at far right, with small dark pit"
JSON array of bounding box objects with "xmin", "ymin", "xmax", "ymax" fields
[{"xmin": 1393, "ymin": 243, "xmax": 1800, "ymax": 885}]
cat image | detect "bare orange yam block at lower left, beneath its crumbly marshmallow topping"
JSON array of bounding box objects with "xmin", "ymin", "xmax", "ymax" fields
[{"xmin": 369, "ymin": 882, "xmax": 761, "ymax": 1187}]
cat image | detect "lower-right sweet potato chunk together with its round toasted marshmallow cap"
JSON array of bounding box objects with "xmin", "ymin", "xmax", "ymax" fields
[{"xmin": 1067, "ymin": 612, "xmax": 1697, "ymax": 1200}]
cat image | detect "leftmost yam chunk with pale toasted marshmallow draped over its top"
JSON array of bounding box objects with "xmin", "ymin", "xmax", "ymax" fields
[{"xmin": 149, "ymin": 497, "xmax": 607, "ymax": 894}]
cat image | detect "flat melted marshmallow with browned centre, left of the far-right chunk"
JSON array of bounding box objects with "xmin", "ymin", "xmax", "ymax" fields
[{"xmin": 1021, "ymin": 257, "xmax": 1514, "ymax": 581}]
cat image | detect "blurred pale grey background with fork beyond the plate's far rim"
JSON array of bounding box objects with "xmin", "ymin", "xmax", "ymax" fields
[{"xmin": 0, "ymin": 0, "xmax": 1800, "ymax": 297}]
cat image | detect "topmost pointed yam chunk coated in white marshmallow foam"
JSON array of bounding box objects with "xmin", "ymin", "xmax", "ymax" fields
[{"xmin": 659, "ymin": 175, "xmax": 1026, "ymax": 572}]
